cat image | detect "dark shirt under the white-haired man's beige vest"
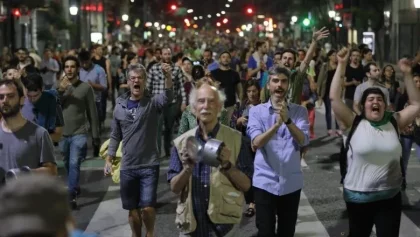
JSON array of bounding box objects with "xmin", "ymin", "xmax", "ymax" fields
[{"xmin": 168, "ymin": 124, "xmax": 254, "ymax": 237}]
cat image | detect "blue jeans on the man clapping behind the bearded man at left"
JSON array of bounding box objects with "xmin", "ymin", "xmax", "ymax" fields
[{"xmin": 59, "ymin": 134, "xmax": 87, "ymax": 199}]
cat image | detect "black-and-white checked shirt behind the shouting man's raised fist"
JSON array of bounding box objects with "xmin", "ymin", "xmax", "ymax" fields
[{"xmin": 147, "ymin": 63, "xmax": 187, "ymax": 104}]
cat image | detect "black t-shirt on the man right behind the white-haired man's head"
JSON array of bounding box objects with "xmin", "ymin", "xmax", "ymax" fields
[{"xmin": 211, "ymin": 68, "xmax": 240, "ymax": 108}]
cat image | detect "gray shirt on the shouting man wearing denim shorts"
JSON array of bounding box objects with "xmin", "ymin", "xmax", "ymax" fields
[{"xmin": 108, "ymin": 89, "xmax": 173, "ymax": 170}]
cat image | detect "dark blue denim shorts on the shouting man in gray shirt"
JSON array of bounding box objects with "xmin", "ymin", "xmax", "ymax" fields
[{"xmin": 120, "ymin": 165, "xmax": 159, "ymax": 210}]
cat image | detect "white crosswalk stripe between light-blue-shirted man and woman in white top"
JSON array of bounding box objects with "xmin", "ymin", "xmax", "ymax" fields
[{"xmin": 295, "ymin": 191, "xmax": 330, "ymax": 237}]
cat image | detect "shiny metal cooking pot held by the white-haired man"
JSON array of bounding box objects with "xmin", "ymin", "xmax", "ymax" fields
[{"xmin": 186, "ymin": 136, "xmax": 225, "ymax": 167}]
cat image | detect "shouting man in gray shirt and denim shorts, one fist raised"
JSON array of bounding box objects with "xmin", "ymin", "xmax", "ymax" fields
[{"xmin": 104, "ymin": 64, "xmax": 173, "ymax": 237}]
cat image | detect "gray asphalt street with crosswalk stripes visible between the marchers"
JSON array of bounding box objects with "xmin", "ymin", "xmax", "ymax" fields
[{"xmin": 57, "ymin": 108, "xmax": 420, "ymax": 237}]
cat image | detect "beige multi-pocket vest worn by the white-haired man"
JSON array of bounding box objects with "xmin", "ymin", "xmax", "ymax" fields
[{"xmin": 174, "ymin": 124, "xmax": 244, "ymax": 233}]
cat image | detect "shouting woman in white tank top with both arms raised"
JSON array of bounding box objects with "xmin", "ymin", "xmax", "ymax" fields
[{"xmin": 330, "ymin": 48, "xmax": 420, "ymax": 237}]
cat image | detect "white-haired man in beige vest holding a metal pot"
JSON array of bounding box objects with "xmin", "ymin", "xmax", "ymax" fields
[{"xmin": 168, "ymin": 84, "xmax": 253, "ymax": 237}]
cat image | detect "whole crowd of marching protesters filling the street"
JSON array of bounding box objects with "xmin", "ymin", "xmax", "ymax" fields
[{"xmin": 0, "ymin": 25, "xmax": 420, "ymax": 237}]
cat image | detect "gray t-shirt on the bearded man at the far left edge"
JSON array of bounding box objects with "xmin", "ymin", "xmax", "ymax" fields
[{"xmin": 0, "ymin": 121, "xmax": 55, "ymax": 182}]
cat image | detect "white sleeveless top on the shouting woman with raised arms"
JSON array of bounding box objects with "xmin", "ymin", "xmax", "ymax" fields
[{"xmin": 344, "ymin": 119, "xmax": 402, "ymax": 192}]
